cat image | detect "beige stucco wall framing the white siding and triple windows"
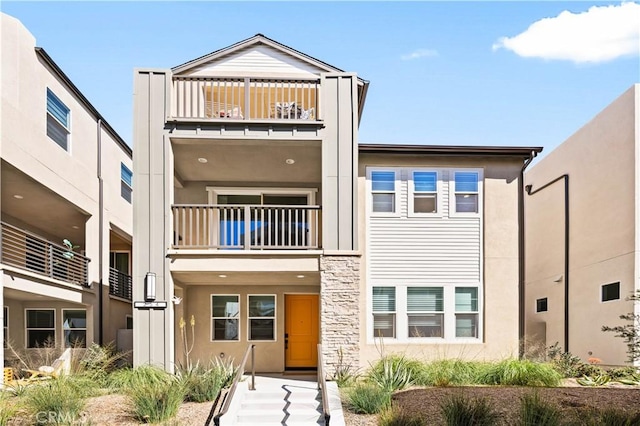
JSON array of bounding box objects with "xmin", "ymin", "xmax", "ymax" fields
[{"xmin": 358, "ymin": 154, "xmax": 523, "ymax": 366}]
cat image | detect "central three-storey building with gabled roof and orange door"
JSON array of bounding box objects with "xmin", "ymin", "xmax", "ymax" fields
[{"xmin": 133, "ymin": 34, "xmax": 541, "ymax": 372}]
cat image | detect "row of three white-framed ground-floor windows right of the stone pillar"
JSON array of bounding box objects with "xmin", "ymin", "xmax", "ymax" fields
[{"xmin": 369, "ymin": 284, "xmax": 482, "ymax": 342}]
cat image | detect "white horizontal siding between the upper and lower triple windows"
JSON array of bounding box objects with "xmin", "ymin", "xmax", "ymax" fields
[{"xmin": 367, "ymin": 168, "xmax": 482, "ymax": 285}]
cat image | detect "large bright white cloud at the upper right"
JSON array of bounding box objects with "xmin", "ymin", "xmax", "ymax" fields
[{"xmin": 493, "ymin": 2, "xmax": 640, "ymax": 63}]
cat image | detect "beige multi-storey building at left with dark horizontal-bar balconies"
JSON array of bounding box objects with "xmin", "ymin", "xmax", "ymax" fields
[{"xmin": 0, "ymin": 14, "xmax": 133, "ymax": 382}]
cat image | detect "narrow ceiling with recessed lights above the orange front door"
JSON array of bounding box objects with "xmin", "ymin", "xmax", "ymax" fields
[{"xmin": 172, "ymin": 271, "xmax": 320, "ymax": 286}]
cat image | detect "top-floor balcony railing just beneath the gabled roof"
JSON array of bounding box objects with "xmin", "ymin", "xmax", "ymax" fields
[{"xmin": 170, "ymin": 76, "xmax": 320, "ymax": 121}]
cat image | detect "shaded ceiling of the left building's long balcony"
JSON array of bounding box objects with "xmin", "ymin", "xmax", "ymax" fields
[{"xmin": 0, "ymin": 161, "xmax": 87, "ymax": 246}]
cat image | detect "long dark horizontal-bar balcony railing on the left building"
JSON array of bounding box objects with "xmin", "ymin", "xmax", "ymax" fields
[{"xmin": 0, "ymin": 222, "xmax": 90, "ymax": 286}]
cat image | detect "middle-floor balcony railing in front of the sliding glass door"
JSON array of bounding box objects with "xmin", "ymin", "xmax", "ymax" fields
[{"xmin": 172, "ymin": 204, "xmax": 320, "ymax": 250}]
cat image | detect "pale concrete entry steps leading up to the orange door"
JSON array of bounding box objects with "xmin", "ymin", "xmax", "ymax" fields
[{"xmin": 220, "ymin": 374, "xmax": 344, "ymax": 426}]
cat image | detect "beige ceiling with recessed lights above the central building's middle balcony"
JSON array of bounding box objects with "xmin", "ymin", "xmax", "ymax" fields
[{"xmin": 172, "ymin": 139, "xmax": 322, "ymax": 184}]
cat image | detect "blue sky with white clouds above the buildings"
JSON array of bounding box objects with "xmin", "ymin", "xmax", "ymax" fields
[{"xmin": 0, "ymin": 1, "xmax": 640, "ymax": 159}]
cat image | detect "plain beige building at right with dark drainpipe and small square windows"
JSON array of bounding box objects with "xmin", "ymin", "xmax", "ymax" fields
[{"xmin": 525, "ymin": 84, "xmax": 640, "ymax": 365}]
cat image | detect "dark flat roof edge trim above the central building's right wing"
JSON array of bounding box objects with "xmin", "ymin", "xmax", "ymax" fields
[{"xmin": 358, "ymin": 144, "xmax": 542, "ymax": 158}]
